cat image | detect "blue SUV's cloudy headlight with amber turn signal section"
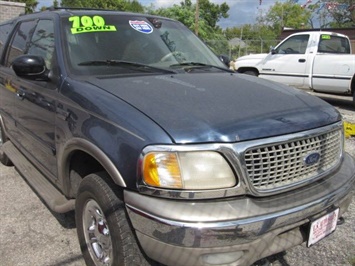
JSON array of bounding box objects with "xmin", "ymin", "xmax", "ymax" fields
[{"xmin": 142, "ymin": 151, "xmax": 236, "ymax": 190}]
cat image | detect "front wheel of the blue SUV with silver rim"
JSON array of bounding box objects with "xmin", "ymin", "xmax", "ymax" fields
[{"xmin": 75, "ymin": 173, "xmax": 149, "ymax": 266}]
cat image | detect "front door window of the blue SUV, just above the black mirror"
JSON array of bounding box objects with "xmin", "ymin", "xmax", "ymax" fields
[{"xmin": 27, "ymin": 20, "xmax": 54, "ymax": 69}]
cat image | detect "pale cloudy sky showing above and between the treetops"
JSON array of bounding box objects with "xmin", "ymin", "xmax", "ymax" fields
[{"xmin": 37, "ymin": 0, "xmax": 292, "ymax": 29}]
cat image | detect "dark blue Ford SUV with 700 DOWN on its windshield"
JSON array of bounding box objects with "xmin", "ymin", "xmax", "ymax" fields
[{"xmin": 0, "ymin": 8, "xmax": 355, "ymax": 266}]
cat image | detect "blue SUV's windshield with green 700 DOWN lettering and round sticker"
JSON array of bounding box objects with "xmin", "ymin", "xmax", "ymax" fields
[{"xmin": 62, "ymin": 13, "xmax": 225, "ymax": 74}]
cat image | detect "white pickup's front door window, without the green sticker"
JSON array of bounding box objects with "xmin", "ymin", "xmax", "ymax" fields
[{"xmin": 276, "ymin": 34, "xmax": 309, "ymax": 54}]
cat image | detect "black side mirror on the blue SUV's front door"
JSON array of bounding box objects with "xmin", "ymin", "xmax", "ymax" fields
[{"xmin": 12, "ymin": 55, "xmax": 49, "ymax": 81}]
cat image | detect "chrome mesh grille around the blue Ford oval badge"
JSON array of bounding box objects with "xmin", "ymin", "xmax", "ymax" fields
[{"xmin": 244, "ymin": 129, "xmax": 342, "ymax": 192}]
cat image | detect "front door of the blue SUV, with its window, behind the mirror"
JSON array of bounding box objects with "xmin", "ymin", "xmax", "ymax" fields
[{"xmin": 6, "ymin": 19, "xmax": 57, "ymax": 176}]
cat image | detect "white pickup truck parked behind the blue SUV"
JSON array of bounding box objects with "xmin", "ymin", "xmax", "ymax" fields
[{"xmin": 235, "ymin": 31, "xmax": 355, "ymax": 105}]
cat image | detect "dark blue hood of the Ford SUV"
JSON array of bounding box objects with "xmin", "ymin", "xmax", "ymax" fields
[{"xmin": 87, "ymin": 73, "xmax": 340, "ymax": 143}]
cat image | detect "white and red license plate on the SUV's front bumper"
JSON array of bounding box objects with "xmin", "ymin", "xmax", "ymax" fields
[{"xmin": 307, "ymin": 208, "xmax": 339, "ymax": 247}]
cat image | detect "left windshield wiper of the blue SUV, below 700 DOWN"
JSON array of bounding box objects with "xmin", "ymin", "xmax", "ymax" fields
[{"xmin": 78, "ymin": 60, "xmax": 176, "ymax": 74}]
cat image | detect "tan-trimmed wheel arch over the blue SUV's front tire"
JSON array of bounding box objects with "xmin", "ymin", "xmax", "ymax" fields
[{"xmin": 58, "ymin": 138, "xmax": 127, "ymax": 198}]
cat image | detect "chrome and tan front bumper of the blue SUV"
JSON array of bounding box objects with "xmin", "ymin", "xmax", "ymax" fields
[{"xmin": 124, "ymin": 154, "xmax": 355, "ymax": 266}]
